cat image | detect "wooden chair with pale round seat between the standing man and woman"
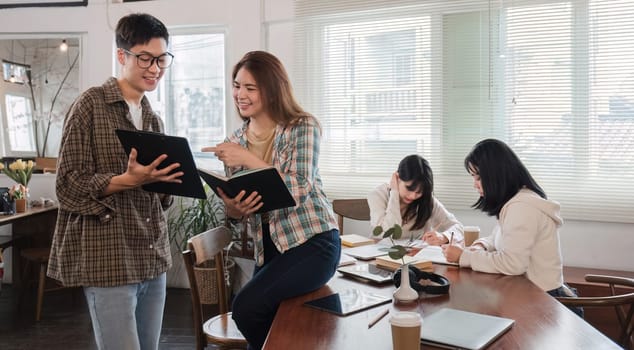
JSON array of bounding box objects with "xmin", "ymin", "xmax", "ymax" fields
[{"xmin": 183, "ymin": 226, "xmax": 247, "ymax": 350}]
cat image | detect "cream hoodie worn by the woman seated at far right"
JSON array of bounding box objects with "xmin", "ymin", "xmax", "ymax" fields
[{"xmin": 460, "ymin": 189, "xmax": 563, "ymax": 291}]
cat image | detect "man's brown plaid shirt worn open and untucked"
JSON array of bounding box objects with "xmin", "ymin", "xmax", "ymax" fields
[{"xmin": 48, "ymin": 78, "xmax": 172, "ymax": 287}]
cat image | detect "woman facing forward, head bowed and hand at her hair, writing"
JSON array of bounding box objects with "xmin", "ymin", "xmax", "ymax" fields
[{"xmin": 368, "ymin": 154, "xmax": 464, "ymax": 245}]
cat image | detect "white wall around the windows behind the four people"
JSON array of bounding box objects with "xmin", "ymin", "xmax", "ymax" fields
[{"xmin": 0, "ymin": 0, "xmax": 634, "ymax": 271}]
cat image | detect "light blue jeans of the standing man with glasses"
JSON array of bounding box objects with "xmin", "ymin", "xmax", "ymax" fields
[{"xmin": 84, "ymin": 273, "xmax": 165, "ymax": 350}]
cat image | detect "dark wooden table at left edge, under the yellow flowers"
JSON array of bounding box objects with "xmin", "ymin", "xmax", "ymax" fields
[{"xmin": 0, "ymin": 205, "xmax": 57, "ymax": 285}]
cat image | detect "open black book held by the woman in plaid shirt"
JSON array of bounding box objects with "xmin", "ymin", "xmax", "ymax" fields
[{"xmin": 198, "ymin": 167, "xmax": 297, "ymax": 213}]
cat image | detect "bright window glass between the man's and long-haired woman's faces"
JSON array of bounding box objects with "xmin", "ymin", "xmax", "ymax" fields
[{"xmin": 148, "ymin": 31, "xmax": 226, "ymax": 168}]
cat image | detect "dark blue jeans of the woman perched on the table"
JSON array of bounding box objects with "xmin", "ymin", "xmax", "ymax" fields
[{"xmin": 232, "ymin": 225, "xmax": 341, "ymax": 349}]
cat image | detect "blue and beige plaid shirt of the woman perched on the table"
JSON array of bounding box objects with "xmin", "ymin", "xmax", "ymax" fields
[{"xmin": 228, "ymin": 117, "xmax": 337, "ymax": 265}]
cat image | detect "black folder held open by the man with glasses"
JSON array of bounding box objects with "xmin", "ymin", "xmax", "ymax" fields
[{"xmin": 115, "ymin": 129, "xmax": 207, "ymax": 199}]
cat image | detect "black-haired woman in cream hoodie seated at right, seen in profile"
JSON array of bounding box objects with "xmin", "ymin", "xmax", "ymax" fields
[{"xmin": 443, "ymin": 139, "xmax": 583, "ymax": 315}]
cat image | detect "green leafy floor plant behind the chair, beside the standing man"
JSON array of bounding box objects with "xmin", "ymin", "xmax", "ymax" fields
[{"xmin": 167, "ymin": 185, "xmax": 228, "ymax": 288}]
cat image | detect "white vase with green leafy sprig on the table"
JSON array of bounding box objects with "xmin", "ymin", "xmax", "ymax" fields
[{"xmin": 372, "ymin": 224, "xmax": 418, "ymax": 303}]
